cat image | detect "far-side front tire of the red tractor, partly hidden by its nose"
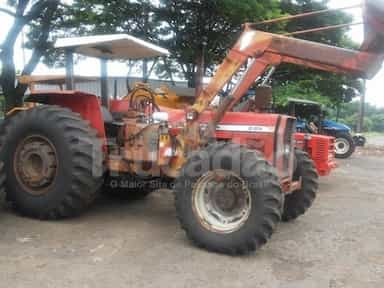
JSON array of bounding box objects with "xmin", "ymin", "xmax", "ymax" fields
[{"xmin": 283, "ymin": 149, "xmax": 319, "ymax": 222}]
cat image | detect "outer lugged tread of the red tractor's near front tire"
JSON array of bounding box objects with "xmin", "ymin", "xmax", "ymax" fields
[{"xmin": 175, "ymin": 142, "xmax": 283, "ymax": 255}]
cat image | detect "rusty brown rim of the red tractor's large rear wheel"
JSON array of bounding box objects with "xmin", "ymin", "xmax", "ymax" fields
[{"xmin": 13, "ymin": 135, "xmax": 58, "ymax": 195}]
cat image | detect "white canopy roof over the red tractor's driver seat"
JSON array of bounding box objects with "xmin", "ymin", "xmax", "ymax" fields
[{"xmin": 55, "ymin": 34, "xmax": 169, "ymax": 60}]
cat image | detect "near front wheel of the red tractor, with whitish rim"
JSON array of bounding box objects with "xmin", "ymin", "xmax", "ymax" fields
[{"xmin": 175, "ymin": 143, "xmax": 284, "ymax": 255}]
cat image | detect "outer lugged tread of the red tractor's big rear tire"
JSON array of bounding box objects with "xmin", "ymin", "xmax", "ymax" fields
[{"xmin": 0, "ymin": 105, "xmax": 102, "ymax": 219}]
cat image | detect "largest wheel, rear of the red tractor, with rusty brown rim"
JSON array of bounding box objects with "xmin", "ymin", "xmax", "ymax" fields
[{"xmin": 0, "ymin": 106, "xmax": 103, "ymax": 219}]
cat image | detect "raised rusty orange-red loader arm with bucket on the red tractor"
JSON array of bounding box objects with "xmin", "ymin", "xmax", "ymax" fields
[{"xmin": 185, "ymin": 0, "xmax": 384, "ymax": 147}]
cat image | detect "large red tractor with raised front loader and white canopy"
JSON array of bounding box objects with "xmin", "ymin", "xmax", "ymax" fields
[{"xmin": 0, "ymin": 1, "xmax": 384, "ymax": 254}]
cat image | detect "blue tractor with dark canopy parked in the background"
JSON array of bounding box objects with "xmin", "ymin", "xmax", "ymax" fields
[{"xmin": 288, "ymin": 98, "xmax": 366, "ymax": 159}]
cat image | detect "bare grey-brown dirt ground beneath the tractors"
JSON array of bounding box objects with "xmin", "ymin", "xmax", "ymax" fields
[{"xmin": 0, "ymin": 153, "xmax": 384, "ymax": 288}]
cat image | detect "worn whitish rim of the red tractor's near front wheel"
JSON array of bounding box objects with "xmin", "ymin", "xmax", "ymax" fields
[{"xmin": 192, "ymin": 170, "xmax": 252, "ymax": 233}]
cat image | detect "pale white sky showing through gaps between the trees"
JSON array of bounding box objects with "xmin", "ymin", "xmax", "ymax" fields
[{"xmin": 0, "ymin": 0, "xmax": 384, "ymax": 107}]
